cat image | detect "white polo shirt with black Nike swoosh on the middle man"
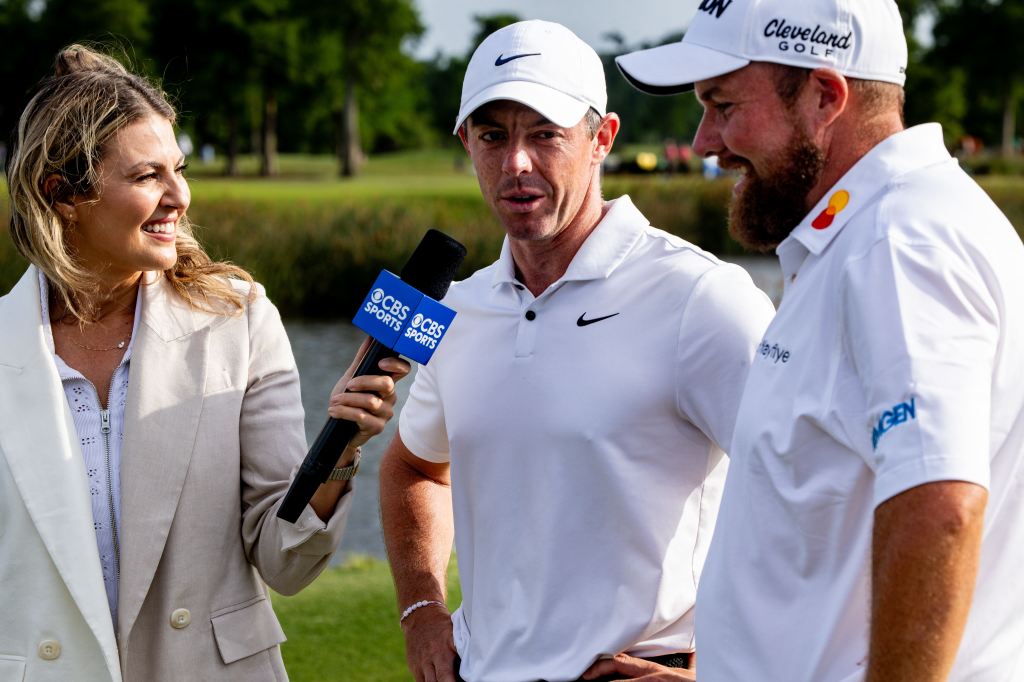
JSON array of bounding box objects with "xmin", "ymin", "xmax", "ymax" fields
[{"xmin": 399, "ymin": 197, "xmax": 773, "ymax": 682}]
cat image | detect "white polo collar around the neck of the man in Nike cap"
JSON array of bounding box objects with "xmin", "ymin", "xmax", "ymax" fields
[{"xmin": 490, "ymin": 195, "xmax": 649, "ymax": 287}]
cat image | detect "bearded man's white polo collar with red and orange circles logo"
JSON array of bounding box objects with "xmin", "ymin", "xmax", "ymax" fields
[{"xmin": 775, "ymin": 123, "xmax": 950, "ymax": 262}]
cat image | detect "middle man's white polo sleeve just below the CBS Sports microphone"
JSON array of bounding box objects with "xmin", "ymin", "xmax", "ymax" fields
[{"xmin": 398, "ymin": 353, "xmax": 450, "ymax": 464}]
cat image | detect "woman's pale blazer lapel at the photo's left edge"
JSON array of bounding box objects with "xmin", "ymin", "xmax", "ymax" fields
[{"xmin": 0, "ymin": 267, "xmax": 121, "ymax": 679}]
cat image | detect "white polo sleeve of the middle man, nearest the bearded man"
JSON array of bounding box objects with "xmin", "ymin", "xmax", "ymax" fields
[{"xmin": 676, "ymin": 264, "xmax": 775, "ymax": 453}]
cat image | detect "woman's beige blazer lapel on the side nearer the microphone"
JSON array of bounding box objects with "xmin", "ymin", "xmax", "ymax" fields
[{"xmin": 118, "ymin": 276, "xmax": 213, "ymax": 645}]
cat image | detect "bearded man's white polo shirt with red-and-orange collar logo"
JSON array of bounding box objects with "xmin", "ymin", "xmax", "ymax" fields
[{"xmin": 697, "ymin": 124, "xmax": 1024, "ymax": 682}]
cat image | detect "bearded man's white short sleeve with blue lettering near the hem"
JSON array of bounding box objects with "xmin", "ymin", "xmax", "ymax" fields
[{"xmin": 841, "ymin": 237, "xmax": 998, "ymax": 505}]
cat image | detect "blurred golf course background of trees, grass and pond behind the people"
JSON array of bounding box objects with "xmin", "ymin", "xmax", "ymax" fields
[{"xmin": 0, "ymin": 0, "xmax": 1024, "ymax": 681}]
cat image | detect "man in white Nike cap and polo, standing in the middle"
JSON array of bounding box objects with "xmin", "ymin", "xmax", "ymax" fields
[{"xmin": 380, "ymin": 22, "xmax": 773, "ymax": 682}]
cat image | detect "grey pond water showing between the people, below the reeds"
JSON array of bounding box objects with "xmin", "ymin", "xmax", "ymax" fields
[{"xmin": 285, "ymin": 257, "xmax": 782, "ymax": 563}]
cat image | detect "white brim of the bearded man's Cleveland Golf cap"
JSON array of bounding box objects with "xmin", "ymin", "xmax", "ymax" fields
[{"xmin": 615, "ymin": 41, "xmax": 751, "ymax": 95}]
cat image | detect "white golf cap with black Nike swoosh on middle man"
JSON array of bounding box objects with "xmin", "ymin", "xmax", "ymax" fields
[{"xmin": 453, "ymin": 20, "xmax": 608, "ymax": 132}]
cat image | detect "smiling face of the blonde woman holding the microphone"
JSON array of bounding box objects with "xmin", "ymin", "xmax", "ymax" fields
[{"xmin": 66, "ymin": 114, "xmax": 190, "ymax": 286}]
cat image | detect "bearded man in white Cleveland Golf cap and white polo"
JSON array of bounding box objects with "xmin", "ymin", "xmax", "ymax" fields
[{"xmin": 587, "ymin": 0, "xmax": 1024, "ymax": 682}]
